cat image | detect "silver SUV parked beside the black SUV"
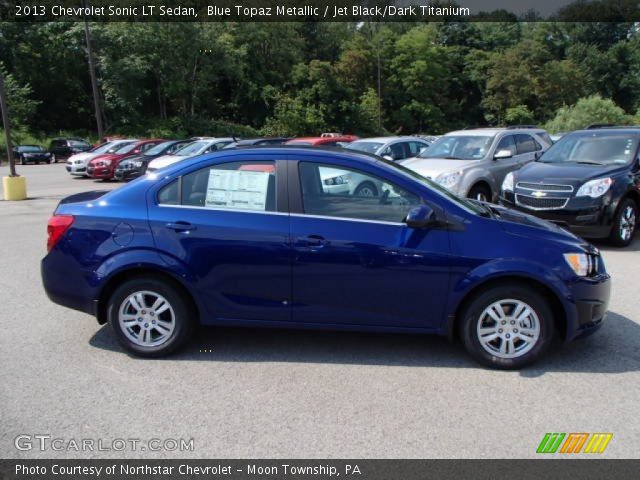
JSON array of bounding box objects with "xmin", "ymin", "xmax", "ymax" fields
[{"xmin": 401, "ymin": 127, "xmax": 553, "ymax": 202}]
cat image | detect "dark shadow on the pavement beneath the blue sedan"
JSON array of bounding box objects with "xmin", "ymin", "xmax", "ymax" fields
[{"xmin": 90, "ymin": 313, "xmax": 640, "ymax": 377}]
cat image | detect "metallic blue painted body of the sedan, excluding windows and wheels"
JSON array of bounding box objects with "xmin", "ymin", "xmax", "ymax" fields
[{"xmin": 42, "ymin": 147, "xmax": 610, "ymax": 339}]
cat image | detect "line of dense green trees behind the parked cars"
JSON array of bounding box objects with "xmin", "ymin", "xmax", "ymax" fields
[{"xmin": 0, "ymin": 21, "xmax": 640, "ymax": 142}]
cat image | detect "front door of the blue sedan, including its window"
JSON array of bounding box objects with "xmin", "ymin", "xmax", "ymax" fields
[{"xmin": 289, "ymin": 160, "xmax": 449, "ymax": 329}]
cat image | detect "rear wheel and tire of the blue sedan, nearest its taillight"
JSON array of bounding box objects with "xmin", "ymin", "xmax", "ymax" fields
[{"xmin": 107, "ymin": 277, "xmax": 195, "ymax": 358}]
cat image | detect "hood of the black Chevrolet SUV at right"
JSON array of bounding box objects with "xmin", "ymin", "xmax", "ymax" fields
[{"xmin": 515, "ymin": 162, "xmax": 626, "ymax": 188}]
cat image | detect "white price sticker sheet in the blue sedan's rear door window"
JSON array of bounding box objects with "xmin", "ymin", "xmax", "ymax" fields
[{"xmin": 205, "ymin": 169, "xmax": 269, "ymax": 211}]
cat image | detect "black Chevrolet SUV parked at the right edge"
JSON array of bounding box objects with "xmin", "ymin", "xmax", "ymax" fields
[{"xmin": 500, "ymin": 127, "xmax": 640, "ymax": 246}]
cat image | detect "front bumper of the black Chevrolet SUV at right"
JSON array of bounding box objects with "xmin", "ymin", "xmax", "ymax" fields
[{"xmin": 500, "ymin": 192, "xmax": 613, "ymax": 238}]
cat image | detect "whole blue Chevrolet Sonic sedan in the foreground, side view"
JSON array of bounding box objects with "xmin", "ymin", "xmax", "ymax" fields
[{"xmin": 42, "ymin": 147, "xmax": 610, "ymax": 368}]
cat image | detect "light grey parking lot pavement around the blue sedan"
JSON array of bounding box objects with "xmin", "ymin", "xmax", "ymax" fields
[{"xmin": 0, "ymin": 165, "xmax": 640, "ymax": 458}]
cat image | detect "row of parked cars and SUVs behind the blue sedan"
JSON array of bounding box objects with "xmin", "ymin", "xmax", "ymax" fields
[{"xmin": 16, "ymin": 125, "xmax": 640, "ymax": 246}]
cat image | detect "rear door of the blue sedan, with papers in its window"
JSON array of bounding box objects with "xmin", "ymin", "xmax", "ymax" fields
[{"xmin": 148, "ymin": 157, "xmax": 291, "ymax": 322}]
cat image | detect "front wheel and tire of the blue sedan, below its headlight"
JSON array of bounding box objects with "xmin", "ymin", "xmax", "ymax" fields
[{"xmin": 460, "ymin": 284, "xmax": 554, "ymax": 370}]
